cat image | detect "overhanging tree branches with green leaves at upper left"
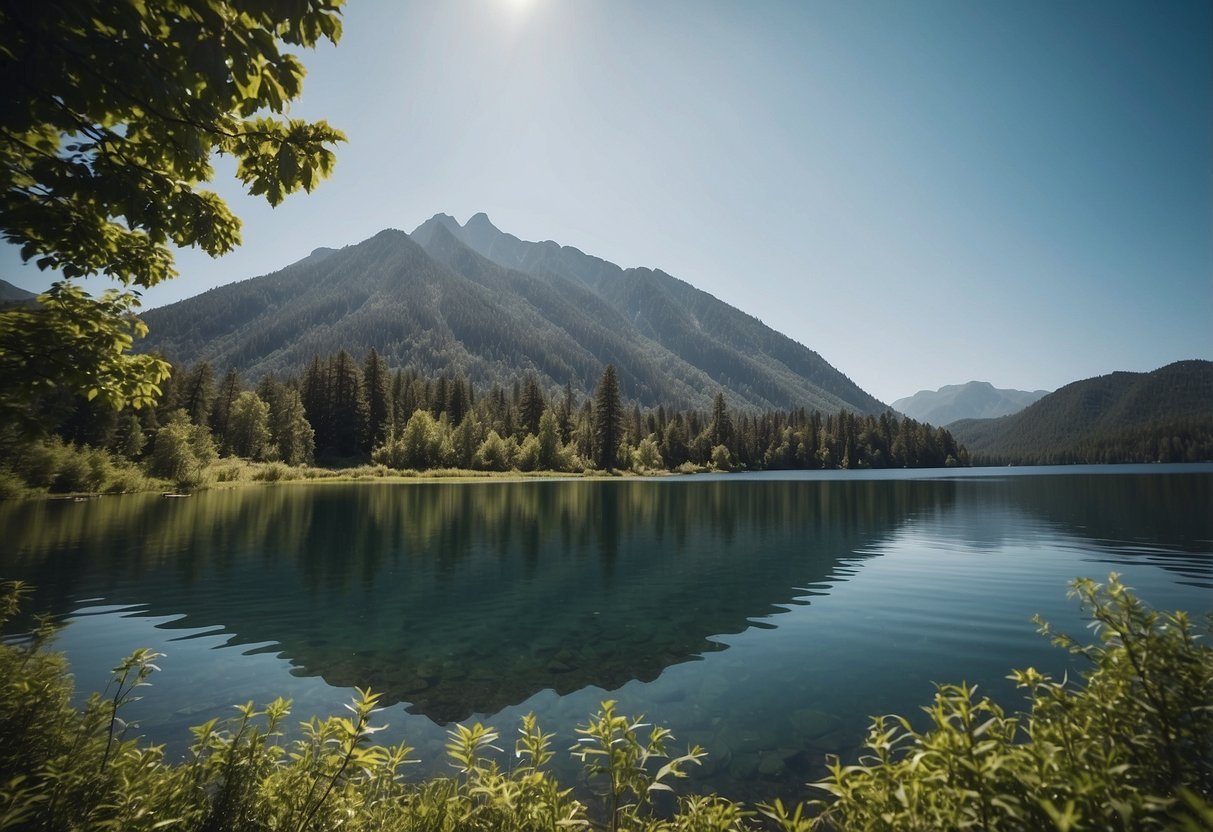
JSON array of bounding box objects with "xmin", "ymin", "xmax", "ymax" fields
[{"xmin": 0, "ymin": 0, "xmax": 344, "ymax": 429}]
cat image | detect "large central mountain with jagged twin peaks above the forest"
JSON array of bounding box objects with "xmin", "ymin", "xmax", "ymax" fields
[{"xmin": 141, "ymin": 213, "xmax": 884, "ymax": 414}]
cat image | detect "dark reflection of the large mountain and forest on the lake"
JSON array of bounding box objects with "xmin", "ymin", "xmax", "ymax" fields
[{"xmin": 2, "ymin": 481, "xmax": 955, "ymax": 722}]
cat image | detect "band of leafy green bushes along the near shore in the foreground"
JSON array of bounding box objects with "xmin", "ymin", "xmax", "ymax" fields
[{"xmin": 0, "ymin": 574, "xmax": 1213, "ymax": 832}]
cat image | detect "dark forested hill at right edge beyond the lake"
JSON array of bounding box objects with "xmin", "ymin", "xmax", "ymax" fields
[{"xmin": 947, "ymin": 360, "xmax": 1213, "ymax": 463}]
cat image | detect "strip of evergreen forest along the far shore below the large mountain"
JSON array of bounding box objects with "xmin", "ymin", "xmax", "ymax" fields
[{"xmin": 0, "ymin": 348, "xmax": 968, "ymax": 495}]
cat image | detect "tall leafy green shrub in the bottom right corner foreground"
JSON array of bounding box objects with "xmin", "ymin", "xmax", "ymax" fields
[{"xmin": 767, "ymin": 574, "xmax": 1213, "ymax": 832}]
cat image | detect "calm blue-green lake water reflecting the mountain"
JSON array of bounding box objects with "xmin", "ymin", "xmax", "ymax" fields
[{"xmin": 0, "ymin": 466, "xmax": 1213, "ymax": 799}]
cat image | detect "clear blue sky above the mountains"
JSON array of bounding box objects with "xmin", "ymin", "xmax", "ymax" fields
[{"xmin": 0, "ymin": 0, "xmax": 1213, "ymax": 401}]
